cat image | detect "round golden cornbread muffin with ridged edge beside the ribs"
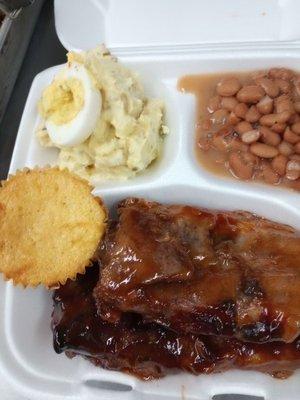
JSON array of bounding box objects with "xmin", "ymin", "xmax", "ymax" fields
[{"xmin": 0, "ymin": 168, "xmax": 107, "ymax": 288}]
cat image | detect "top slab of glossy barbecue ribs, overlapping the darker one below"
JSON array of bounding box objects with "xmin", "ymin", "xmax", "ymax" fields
[{"xmin": 94, "ymin": 199, "xmax": 300, "ymax": 343}]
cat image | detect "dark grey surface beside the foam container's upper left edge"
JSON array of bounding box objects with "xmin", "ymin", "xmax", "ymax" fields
[{"xmin": 0, "ymin": 0, "xmax": 66, "ymax": 180}]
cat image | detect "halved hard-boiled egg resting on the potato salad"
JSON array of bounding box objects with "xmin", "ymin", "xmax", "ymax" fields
[{"xmin": 39, "ymin": 62, "xmax": 102, "ymax": 147}]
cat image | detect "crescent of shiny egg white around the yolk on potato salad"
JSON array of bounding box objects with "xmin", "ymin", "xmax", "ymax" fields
[{"xmin": 45, "ymin": 62, "xmax": 102, "ymax": 147}]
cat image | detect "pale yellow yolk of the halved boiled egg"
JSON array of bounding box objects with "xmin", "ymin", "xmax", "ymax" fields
[{"xmin": 39, "ymin": 78, "xmax": 84, "ymax": 125}]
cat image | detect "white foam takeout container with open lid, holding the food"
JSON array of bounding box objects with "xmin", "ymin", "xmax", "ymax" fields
[{"xmin": 0, "ymin": 0, "xmax": 300, "ymax": 400}]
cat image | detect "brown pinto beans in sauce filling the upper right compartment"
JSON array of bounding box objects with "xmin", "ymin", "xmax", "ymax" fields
[{"xmin": 178, "ymin": 68, "xmax": 300, "ymax": 190}]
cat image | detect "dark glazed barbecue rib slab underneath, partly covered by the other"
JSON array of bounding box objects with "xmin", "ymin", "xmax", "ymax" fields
[{"xmin": 52, "ymin": 265, "xmax": 300, "ymax": 379}]
